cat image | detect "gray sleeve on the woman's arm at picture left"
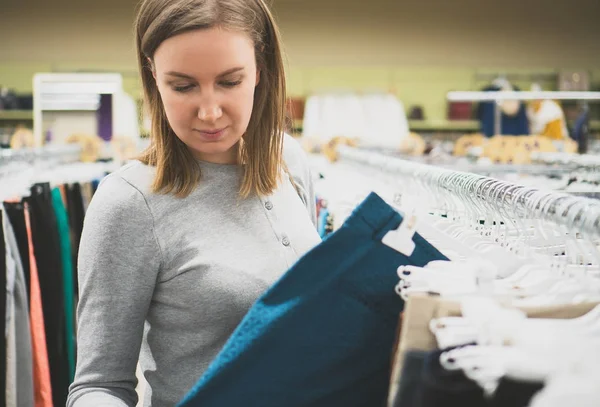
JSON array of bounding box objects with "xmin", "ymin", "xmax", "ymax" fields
[{"xmin": 67, "ymin": 175, "xmax": 161, "ymax": 407}]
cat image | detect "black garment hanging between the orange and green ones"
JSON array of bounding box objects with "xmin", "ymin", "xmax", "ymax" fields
[{"xmin": 26, "ymin": 183, "xmax": 69, "ymax": 406}]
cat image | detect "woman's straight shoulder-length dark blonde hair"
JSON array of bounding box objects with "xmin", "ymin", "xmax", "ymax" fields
[{"xmin": 135, "ymin": 0, "xmax": 287, "ymax": 197}]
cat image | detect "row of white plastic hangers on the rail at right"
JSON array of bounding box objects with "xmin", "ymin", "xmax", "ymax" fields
[{"xmin": 324, "ymin": 147, "xmax": 600, "ymax": 407}]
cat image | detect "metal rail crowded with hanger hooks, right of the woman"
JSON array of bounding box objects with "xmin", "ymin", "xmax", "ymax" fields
[{"xmin": 338, "ymin": 146, "xmax": 600, "ymax": 238}]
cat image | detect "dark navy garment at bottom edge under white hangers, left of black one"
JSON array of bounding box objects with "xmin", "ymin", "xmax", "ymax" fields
[{"xmin": 414, "ymin": 349, "xmax": 485, "ymax": 407}]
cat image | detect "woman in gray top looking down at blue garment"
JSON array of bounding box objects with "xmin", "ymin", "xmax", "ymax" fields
[{"xmin": 67, "ymin": 0, "xmax": 319, "ymax": 407}]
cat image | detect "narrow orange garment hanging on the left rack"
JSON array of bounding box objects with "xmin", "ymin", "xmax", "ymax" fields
[{"xmin": 24, "ymin": 204, "xmax": 53, "ymax": 407}]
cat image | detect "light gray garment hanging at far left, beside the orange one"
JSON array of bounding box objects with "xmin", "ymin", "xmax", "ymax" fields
[{"xmin": 2, "ymin": 211, "xmax": 33, "ymax": 407}]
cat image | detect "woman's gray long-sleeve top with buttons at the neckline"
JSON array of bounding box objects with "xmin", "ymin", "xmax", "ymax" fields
[{"xmin": 67, "ymin": 136, "xmax": 320, "ymax": 407}]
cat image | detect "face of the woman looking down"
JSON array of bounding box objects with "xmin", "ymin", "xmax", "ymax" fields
[{"xmin": 153, "ymin": 28, "xmax": 259, "ymax": 164}]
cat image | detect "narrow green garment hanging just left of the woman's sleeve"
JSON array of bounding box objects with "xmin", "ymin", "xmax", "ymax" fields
[{"xmin": 52, "ymin": 188, "xmax": 76, "ymax": 383}]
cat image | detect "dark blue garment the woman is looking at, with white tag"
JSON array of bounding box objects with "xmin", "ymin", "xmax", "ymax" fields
[{"xmin": 180, "ymin": 193, "xmax": 445, "ymax": 407}]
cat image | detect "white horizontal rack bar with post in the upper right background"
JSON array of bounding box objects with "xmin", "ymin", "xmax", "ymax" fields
[{"xmin": 446, "ymin": 91, "xmax": 600, "ymax": 134}]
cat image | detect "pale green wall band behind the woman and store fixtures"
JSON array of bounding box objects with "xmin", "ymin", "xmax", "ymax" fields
[{"xmin": 0, "ymin": 64, "xmax": 600, "ymax": 120}]
